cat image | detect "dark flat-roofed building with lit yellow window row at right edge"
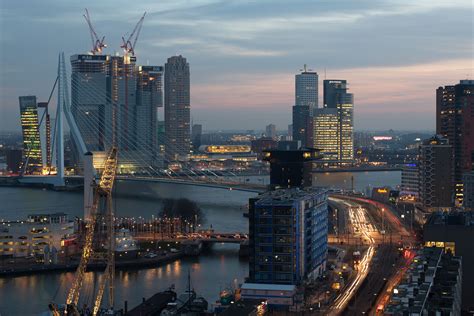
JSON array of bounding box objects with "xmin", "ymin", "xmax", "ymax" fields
[{"xmin": 423, "ymin": 211, "xmax": 474, "ymax": 315}]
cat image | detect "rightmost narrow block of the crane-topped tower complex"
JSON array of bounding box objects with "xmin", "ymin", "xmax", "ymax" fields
[{"xmin": 136, "ymin": 66, "xmax": 164, "ymax": 166}]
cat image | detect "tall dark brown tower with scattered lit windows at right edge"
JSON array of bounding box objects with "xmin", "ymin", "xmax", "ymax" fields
[{"xmin": 436, "ymin": 80, "xmax": 474, "ymax": 205}]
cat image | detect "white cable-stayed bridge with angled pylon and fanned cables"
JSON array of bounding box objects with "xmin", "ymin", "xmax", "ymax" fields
[{"xmin": 20, "ymin": 53, "xmax": 265, "ymax": 192}]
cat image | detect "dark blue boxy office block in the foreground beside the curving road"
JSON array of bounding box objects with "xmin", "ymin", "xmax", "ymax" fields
[{"xmin": 248, "ymin": 188, "xmax": 328, "ymax": 285}]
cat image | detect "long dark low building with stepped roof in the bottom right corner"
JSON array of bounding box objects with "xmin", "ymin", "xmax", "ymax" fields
[{"xmin": 383, "ymin": 247, "xmax": 465, "ymax": 316}]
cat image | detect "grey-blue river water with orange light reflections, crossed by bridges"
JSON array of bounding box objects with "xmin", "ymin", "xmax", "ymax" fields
[{"xmin": 0, "ymin": 171, "xmax": 400, "ymax": 316}]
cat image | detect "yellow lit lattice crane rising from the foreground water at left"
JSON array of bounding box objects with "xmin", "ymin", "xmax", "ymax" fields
[{"xmin": 57, "ymin": 147, "xmax": 117, "ymax": 315}]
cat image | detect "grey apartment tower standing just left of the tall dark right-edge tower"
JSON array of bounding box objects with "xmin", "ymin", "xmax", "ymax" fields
[{"xmin": 419, "ymin": 135, "xmax": 453, "ymax": 211}]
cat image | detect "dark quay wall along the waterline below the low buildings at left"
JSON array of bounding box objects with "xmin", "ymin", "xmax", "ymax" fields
[{"xmin": 0, "ymin": 251, "xmax": 184, "ymax": 278}]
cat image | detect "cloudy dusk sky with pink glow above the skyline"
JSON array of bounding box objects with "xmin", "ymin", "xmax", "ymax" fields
[{"xmin": 0, "ymin": 0, "xmax": 474, "ymax": 131}]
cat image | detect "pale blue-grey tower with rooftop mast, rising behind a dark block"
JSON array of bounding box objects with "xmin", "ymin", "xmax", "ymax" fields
[{"xmin": 295, "ymin": 65, "xmax": 319, "ymax": 111}]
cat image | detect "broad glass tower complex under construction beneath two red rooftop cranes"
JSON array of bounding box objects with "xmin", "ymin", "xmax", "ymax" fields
[{"xmin": 71, "ymin": 55, "xmax": 163, "ymax": 173}]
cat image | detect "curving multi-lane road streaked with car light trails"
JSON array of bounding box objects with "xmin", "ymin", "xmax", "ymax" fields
[{"xmin": 328, "ymin": 196, "xmax": 416, "ymax": 315}]
